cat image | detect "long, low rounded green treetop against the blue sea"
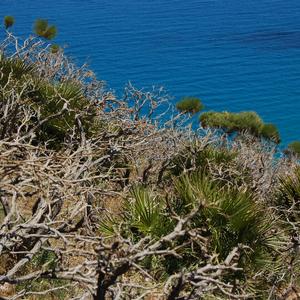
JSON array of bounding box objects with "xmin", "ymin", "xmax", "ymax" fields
[{"xmin": 200, "ymin": 111, "xmax": 280, "ymax": 143}]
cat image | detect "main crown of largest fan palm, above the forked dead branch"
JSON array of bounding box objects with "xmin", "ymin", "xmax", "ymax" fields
[{"xmin": 175, "ymin": 172, "xmax": 279, "ymax": 268}]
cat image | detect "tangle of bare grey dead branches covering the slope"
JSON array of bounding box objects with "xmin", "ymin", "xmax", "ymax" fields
[{"xmin": 0, "ymin": 35, "xmax": 298, "ymax": 300}]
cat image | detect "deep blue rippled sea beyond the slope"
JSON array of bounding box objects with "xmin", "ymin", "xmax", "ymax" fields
[{"xmin": 0, "ymin": 0, "xmax": 300, "ymax": 144}]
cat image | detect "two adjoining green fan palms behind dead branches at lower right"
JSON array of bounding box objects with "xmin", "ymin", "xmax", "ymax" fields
[{"xmin": 100, "ymin": 164, "xmax": 284, "ymax": 296}]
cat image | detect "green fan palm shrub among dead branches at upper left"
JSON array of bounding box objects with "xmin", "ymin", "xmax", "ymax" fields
[{"xmin": 0, "ymin": 54, "xmax": 98, "ymax": 149}]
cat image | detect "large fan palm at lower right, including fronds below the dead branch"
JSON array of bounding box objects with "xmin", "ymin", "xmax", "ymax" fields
[{"xmin": 152, "ymin": 171, "xmax": 285, "ymax": 290}]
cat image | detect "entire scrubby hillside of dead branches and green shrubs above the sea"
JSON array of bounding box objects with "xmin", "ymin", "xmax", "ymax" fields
[{"xmin": 0, "ymin": 21, "xmax": 300, "ymax": 300}]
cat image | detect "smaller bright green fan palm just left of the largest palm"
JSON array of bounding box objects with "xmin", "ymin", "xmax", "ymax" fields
[{"xmin": 99, "ymin": 185, "xmax": 173, "ymax": 277}]
